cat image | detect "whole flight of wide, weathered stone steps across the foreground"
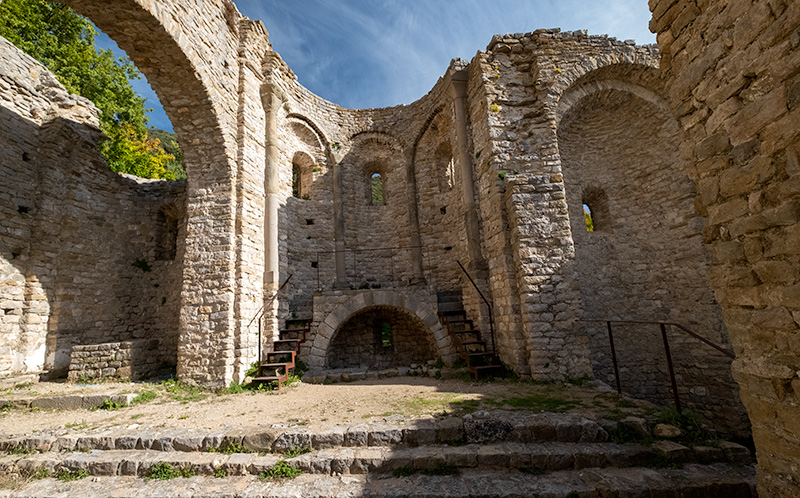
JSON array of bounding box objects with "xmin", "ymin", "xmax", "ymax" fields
[{"xmin": 0, "ymin": 411, "xmax": 755, "ymax": 498}]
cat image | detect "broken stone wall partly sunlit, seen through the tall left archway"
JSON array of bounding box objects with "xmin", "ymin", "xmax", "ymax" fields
[{"xmin": 0, "ymin": 39, "xmax": 185, "ymax": 382}]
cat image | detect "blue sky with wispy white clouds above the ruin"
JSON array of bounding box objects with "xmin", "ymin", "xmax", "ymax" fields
[{"xmin": 98, "ymin": 0, "xmax": 655, "ymax": 130}]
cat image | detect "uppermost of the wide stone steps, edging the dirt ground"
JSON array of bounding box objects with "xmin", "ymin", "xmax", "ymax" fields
[{"xmin": 0, "ymin": 410, "xmax": 751, "ymax": 463}]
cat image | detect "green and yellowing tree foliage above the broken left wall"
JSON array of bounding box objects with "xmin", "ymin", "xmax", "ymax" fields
[{"xmin": 0, "ymin": 0, "xmax": 185, "ymax": 178}]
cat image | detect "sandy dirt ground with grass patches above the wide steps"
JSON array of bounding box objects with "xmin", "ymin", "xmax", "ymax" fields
[{"xmin": 0, "ymin": 377, "xmax": 651, "ymax": 435}]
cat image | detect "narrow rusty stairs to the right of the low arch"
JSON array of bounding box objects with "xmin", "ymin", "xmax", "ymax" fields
[{"xmin": 436, "ymin": 291, "xmax": 503, "ymax": 382}]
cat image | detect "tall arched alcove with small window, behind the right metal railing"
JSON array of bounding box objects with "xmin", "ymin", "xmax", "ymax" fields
[{"xmin": 558, "ymin": 74, "xmax": 742, "ymax": 430}]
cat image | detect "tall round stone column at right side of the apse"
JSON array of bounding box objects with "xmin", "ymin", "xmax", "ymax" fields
[{"xmin": 447, "ymin": 70, "xmax": 483, "ymax": 270}]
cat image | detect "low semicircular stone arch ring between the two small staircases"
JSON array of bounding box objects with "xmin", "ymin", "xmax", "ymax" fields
[{"xmin": 308, "ymin": 290, "xmax": 455, "ymax": 369}]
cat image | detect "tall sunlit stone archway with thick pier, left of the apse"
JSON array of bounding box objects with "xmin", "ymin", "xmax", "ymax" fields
[{"xmin": 55, "ymin": 0, "xmax": 269, "ymax": 385}]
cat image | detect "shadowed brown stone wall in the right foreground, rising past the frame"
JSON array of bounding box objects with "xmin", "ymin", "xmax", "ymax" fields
[{"xmin": 650, "ymin": 0, "xmax": 800, "ymax": 497}]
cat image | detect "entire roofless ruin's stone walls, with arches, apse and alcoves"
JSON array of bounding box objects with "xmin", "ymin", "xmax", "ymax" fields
[{"xmin": 0, "ymin": 0, "xmax": 800, "ymax": 496}]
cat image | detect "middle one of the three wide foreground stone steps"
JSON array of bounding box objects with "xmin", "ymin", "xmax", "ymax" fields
[{"xmin": 0, "ymin": 443, "xmax": 752, "ymax": 477}]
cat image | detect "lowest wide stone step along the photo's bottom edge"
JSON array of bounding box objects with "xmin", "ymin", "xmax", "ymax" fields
[{"xmin": 6, "ymin": 464, "xmax": 756, "ymax": 498}]
